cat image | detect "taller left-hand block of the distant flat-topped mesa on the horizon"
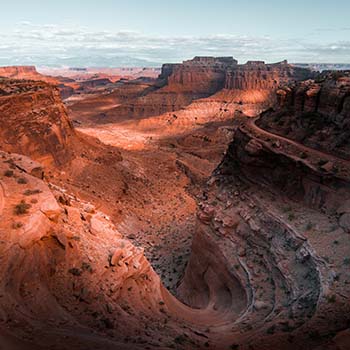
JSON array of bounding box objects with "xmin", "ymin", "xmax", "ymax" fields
[{"xmin": 160, "ymin": 56, "xmax": 238, "ymax": 95}]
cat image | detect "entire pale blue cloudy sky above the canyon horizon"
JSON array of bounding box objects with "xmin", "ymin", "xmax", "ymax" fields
[{"xmin": 0, "ymin": 0, "xmax": 350, "ymax": 66}]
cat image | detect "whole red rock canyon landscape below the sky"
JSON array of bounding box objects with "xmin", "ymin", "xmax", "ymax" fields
[{"xmin": 0, "ymin": 57, "xmax": 350, "ymax": 350}]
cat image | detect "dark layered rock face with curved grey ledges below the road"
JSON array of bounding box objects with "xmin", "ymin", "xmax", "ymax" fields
[{"xmin": 179, "ymin": 113, "xmax": 350, "ymax": 349}]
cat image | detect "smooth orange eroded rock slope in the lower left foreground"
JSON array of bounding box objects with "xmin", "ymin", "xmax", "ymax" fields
[{"xmin": 0, "ymin": 152, "xmax": 175, "ymax": 349}]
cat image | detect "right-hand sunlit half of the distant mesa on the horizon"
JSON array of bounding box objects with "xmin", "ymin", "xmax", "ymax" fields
[{"xmin": 225, "ymin": 61, "xmax": 312, "ymax": 90}]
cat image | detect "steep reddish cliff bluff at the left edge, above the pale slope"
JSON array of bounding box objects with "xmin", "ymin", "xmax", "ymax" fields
[{"xmin": 0, "ymin": 79, "xmax": 75, "ymax": 165}]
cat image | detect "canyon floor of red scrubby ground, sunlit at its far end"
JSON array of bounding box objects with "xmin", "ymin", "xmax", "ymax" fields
[{"xmin": 64, "ymin": 89, "xmax": 243, "ymax": 294}]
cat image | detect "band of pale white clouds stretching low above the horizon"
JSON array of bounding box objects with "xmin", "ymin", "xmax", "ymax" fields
[{"xmin": 0, "ymin": 22, "xmax": 350, "ymax": 66}]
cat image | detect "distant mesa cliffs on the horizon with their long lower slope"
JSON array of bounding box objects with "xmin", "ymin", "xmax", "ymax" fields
[{"xmin": 101, "ymin": 57, "xmax": 312, "ymax": 122}]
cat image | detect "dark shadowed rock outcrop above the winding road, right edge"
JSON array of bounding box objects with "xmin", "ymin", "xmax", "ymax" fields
[{"xmin": 259, "ymin": 72, "xmax": 350, "ymax": 159}]
